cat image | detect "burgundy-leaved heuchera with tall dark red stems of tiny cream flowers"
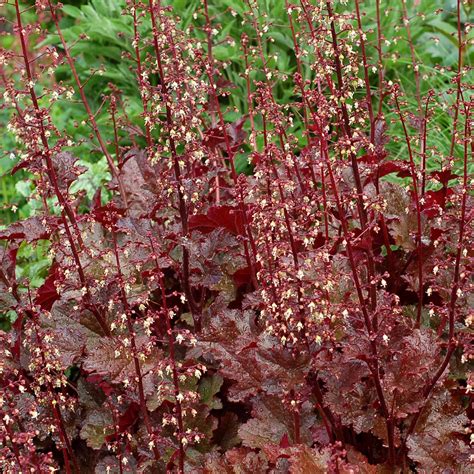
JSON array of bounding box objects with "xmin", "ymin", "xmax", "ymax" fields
[{"xmin": 0, "ymin": 0, "xmax": 474, "ymax": 474}]
